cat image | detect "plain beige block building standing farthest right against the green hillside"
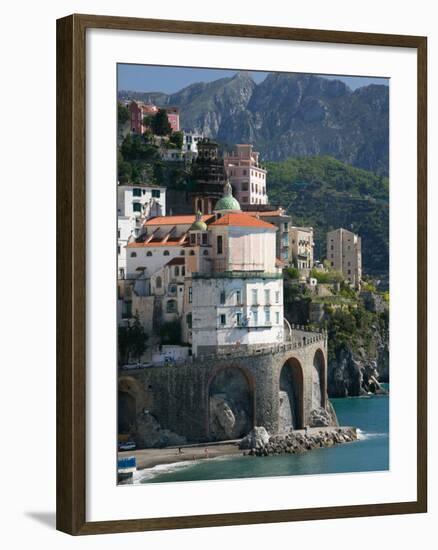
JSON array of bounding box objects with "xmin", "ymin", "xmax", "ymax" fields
[{"xmin": 327, "ymin": 228, "xmax": 362, "ymax": 288}]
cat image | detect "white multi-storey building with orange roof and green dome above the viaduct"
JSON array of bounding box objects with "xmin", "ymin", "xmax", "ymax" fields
[{"xmin": 183, "ymin": 184, "xmax": 283, "ymax": 356}]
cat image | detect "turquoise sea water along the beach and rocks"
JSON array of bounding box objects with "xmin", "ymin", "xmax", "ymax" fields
[{"xmin": 136, "ymin": 396, "xmax": 389, "ymax": 483}]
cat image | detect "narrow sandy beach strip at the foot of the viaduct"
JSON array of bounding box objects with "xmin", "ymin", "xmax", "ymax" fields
[{"xmin": 118, "ymin": 440, "xmax": 244, "ymax": 470}]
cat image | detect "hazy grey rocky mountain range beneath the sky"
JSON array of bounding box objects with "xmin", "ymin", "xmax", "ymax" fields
[{"xmin": 119, "ymin": 72, "xmax": 389, "ymax": 175}]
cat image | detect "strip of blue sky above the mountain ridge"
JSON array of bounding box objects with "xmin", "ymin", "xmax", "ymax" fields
[{"xmin": 118, "ymin": 64, "xmax": 389, "ymax": 94}]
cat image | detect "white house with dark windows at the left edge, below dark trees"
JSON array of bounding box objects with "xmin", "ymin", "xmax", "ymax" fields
[{"xmin": 117, "ymin": 184, "xmax": 166, "ymax": 219}]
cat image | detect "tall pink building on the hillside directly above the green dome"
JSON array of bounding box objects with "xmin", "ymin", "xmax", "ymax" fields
[{"xmin": 224, "ymin": 144, "xmax": 268, "ymax": 209}]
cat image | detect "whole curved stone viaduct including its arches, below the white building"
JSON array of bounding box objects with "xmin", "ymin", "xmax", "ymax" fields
[{"xmin": 118, "ymin": 330, "xmax": 327, "ymax": 442}]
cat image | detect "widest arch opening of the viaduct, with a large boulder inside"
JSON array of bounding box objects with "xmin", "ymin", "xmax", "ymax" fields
[{"xmin": 206, "ymin": 365, "xmax": 255, "ymax": 441}]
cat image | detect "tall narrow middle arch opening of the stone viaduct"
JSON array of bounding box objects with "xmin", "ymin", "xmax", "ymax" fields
[{"xmin": 278, "ymin": 357, "xmax": 304, "ymax": 432}]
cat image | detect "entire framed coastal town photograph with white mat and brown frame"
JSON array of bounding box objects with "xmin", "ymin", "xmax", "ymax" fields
[{"xmin": 57, "ymin": 15, "xmax": 427, "ymax": 535}]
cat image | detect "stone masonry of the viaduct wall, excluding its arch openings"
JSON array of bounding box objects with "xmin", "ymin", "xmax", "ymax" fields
[{"xmin": 119, "ymin": 333, "xmax": 327, "ymax": 442}]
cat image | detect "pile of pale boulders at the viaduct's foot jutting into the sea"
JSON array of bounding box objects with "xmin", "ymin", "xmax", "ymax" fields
[{"xmin": 239, "ymin": 427, "xmax": 357, "ymax": 456}]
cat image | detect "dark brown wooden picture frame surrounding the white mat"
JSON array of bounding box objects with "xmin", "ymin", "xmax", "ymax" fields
[{"xmin": 57, "ymin": 15, "xmax": 427, "ymax": 535}]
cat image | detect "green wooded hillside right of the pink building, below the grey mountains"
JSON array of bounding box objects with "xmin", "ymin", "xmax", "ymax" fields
[{"xmin": 266, "ymin": 156, "xmax": 389, "ymax": 275}]
